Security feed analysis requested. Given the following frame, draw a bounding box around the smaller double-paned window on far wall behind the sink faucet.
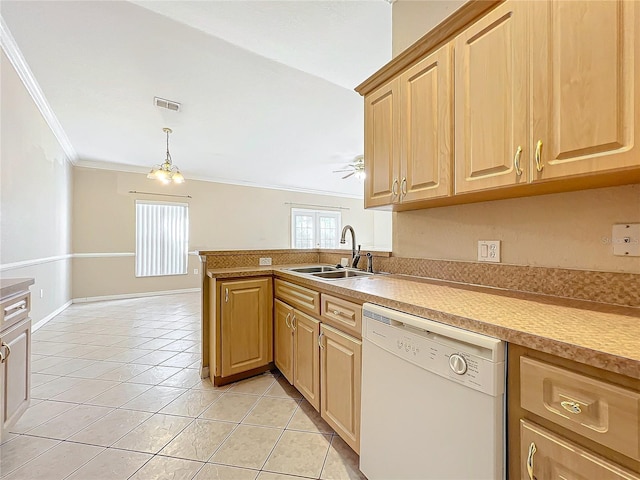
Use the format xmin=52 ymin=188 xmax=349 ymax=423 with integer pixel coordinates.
xmin=291 ymin=208 xmax=342 ymax=248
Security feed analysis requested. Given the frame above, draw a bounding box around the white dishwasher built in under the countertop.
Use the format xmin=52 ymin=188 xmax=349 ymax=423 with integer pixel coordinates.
xmin=360 ymin=303 xmax=506 ymax=480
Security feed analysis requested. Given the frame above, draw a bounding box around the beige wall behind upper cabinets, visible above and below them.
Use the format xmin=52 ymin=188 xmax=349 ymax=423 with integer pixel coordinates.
xmin=393 ymin=0 xmax=640 ymax=273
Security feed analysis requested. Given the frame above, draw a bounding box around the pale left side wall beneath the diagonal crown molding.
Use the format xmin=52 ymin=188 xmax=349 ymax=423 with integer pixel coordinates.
xmin=0 ymin=52 xmax=72 ymax=323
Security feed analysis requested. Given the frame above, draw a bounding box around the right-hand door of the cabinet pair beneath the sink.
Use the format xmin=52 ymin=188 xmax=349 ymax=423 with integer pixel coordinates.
xmin=293 ymin=311 xmax=320 ymax=411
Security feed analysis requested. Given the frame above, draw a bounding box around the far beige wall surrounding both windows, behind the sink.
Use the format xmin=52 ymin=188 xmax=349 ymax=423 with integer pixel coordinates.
xmin=73 ymin=168 xmax=391 ymax=298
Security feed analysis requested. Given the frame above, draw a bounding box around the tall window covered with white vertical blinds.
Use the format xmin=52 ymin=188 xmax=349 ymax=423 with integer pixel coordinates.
xmin=136 ymin=200 xmax=189 ymax=277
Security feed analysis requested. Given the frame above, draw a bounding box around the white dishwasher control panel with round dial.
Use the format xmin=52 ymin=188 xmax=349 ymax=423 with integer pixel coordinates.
xmin=362 ymin=310 xmax=505 ymax=395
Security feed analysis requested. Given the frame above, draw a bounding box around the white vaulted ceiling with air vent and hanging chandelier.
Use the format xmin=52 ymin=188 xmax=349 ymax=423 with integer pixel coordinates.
xmin=0 ymin=0 xmax=391 ymax=197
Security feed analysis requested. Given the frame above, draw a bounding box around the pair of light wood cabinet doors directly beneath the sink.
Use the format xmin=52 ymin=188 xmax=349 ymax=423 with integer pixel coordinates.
xmin=274 ymin=299 xmax=320 ymax=411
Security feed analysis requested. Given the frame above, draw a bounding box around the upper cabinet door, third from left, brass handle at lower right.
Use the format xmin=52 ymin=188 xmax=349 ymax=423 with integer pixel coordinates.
xmin=455 ymin=1 xmax=530 ymax=193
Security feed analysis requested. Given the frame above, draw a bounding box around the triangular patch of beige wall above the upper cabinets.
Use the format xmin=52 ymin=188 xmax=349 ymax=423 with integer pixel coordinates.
xmin=391 ymin=0 xmax=466 ymax=57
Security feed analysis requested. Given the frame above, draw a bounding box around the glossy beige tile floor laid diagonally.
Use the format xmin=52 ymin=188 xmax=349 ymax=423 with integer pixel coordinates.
xmin=0 ymin=293 xmax=364 ymax=480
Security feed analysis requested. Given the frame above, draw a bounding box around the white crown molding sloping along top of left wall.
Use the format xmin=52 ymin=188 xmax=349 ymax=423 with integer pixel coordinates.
xmin=0 ymin=15 xmax=78 ymax=165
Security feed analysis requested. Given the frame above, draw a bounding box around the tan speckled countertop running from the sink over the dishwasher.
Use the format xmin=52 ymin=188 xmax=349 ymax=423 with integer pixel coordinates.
xmin=207 ymin=265 xmax=640 ymax=379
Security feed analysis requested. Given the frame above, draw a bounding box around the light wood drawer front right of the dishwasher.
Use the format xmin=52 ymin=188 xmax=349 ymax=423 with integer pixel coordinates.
xmin=520 ymin=357 xmax=640 ymax=460
